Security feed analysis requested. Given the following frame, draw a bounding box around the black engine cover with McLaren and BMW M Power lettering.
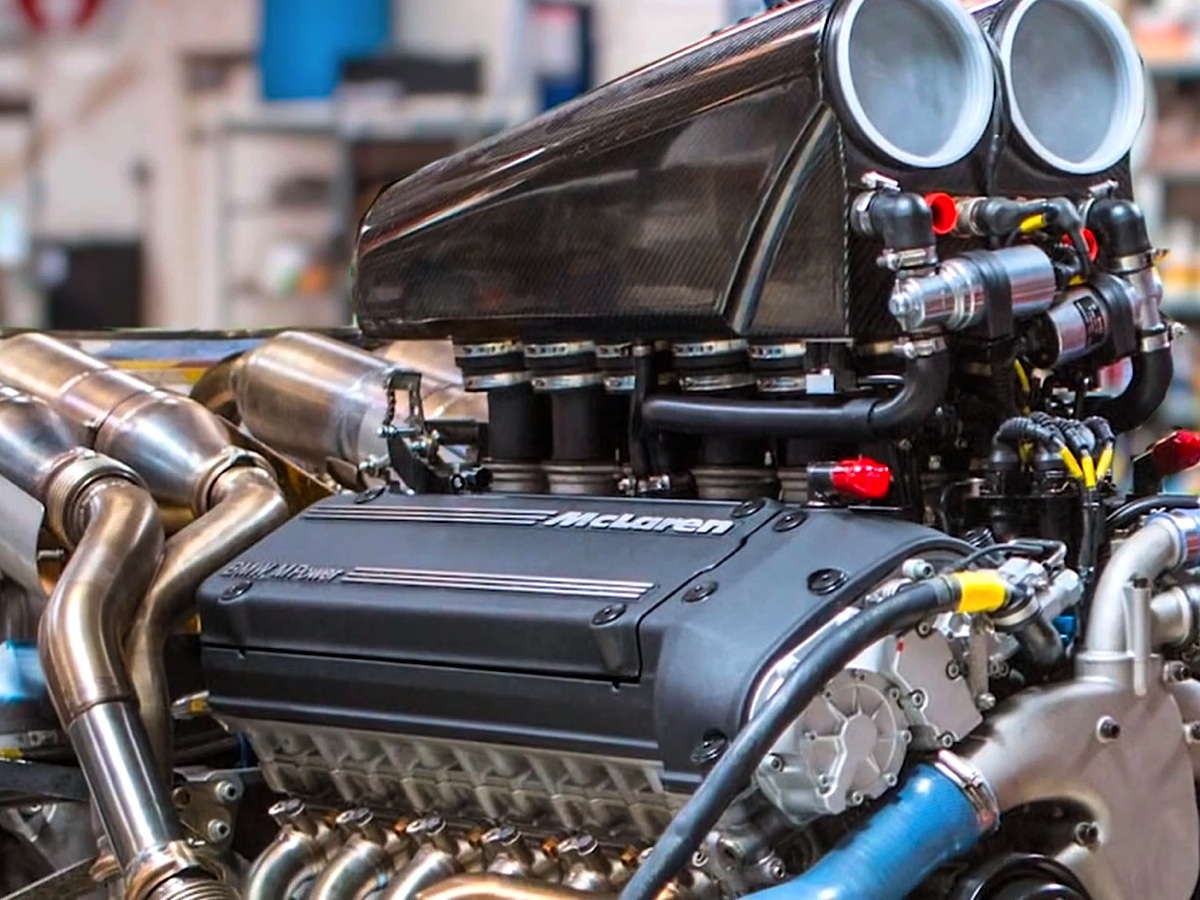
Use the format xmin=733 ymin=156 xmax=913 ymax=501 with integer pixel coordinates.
xmin=199 ymin=494 xmax=962 ymax=785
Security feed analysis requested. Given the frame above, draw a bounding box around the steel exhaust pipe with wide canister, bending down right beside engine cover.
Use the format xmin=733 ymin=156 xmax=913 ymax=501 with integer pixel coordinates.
xmin=0 ymin=334 xmax=288 ymax=778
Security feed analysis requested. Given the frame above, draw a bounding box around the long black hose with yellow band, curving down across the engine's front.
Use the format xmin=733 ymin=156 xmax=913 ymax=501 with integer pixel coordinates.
xmin=618 ymin=576 xmax=984 ymax=900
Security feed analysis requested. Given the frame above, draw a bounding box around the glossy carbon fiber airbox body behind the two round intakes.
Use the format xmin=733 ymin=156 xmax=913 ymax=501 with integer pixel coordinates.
xmin=354 ymin=0 xmax=1128 ymax=340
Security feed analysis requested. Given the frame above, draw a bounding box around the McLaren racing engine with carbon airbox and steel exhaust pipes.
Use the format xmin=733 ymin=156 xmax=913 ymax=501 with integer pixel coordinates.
xmin=0 ymin=0 xmax=1200 ymax=900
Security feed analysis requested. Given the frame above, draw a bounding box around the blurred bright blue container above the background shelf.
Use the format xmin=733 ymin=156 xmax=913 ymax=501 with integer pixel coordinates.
xmin=258 ymin=0 xmax=391 ymax=100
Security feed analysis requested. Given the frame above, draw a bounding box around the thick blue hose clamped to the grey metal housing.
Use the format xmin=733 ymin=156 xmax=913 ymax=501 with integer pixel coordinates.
xmin=750 ymin=766 xmax=992 ymax=900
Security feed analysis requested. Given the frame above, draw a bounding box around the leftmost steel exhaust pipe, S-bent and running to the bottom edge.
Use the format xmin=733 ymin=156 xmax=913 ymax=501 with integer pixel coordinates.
xmin=0 ymin=391 xmax=232 ymax=900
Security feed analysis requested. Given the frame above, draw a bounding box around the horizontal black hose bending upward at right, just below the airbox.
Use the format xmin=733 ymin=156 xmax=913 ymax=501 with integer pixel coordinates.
xmin=642 ymin=352 xmax=950 ymax=442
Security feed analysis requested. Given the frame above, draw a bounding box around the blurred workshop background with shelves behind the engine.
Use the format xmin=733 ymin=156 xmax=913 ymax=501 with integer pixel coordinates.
xmin=0 ymin=0 xmax=1200 ymax=458
